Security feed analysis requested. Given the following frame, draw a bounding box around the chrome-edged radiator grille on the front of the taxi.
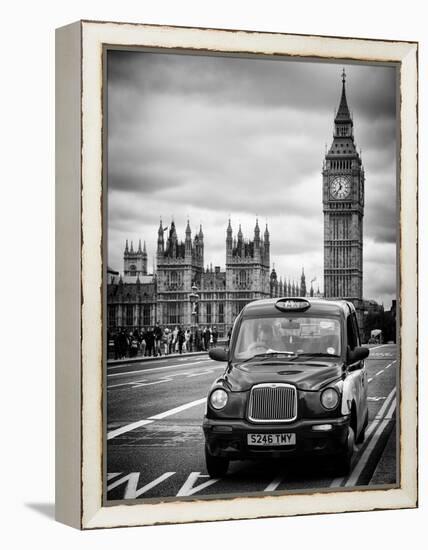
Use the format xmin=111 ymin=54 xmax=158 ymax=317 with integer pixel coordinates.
xmin=248 ymin=384 xmax=297 ymax=422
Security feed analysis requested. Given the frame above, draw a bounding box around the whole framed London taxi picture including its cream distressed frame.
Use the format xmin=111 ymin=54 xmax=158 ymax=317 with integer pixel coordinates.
xmin=56 ymin=21 xmax=418 ymax=529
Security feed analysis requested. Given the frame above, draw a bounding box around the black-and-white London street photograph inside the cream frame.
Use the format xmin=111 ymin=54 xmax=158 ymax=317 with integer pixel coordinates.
xmin=103 ymin=47 xmax=400 ymax=504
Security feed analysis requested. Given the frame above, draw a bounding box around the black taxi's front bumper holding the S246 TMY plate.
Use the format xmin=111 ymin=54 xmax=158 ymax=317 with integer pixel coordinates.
xmin=202 ymin=416 xmax=350 ymax=460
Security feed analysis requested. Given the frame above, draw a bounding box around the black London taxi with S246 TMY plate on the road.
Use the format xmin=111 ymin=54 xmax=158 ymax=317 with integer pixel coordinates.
xmin=203 ymin=298 xmax=369 ymax=477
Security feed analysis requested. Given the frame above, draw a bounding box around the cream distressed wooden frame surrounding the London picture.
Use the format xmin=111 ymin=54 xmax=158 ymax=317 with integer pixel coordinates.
xmin=56 ymin=21 xmax=418 ymax=529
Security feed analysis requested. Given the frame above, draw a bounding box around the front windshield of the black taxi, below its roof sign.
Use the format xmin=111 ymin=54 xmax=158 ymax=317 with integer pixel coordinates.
xmin=233 ymin=315 xmax=341 ymax=361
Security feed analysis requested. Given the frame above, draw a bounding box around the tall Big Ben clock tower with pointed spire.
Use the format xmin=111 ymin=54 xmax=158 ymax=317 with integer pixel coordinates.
xmin=323 ymin=70 xmax=364 ymax=329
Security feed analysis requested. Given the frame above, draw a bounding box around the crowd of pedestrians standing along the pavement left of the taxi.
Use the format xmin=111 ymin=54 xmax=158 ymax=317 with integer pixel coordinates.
xmin=107 ymin=323 xmax=218 ymax=359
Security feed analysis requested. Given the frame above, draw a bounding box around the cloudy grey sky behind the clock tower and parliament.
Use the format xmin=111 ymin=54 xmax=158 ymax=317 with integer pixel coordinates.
xmin=107 ymin=51 xmax=396 ymax=308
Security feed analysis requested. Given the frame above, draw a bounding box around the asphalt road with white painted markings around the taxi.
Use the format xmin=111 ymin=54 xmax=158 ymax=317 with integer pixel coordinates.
xmin=106 ymin=344 xmax=397 ymax=501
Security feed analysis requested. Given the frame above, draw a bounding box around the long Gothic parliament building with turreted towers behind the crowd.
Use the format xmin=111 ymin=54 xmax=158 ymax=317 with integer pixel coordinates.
xmin=107 ymin=220 xmax=313 ymax=336
